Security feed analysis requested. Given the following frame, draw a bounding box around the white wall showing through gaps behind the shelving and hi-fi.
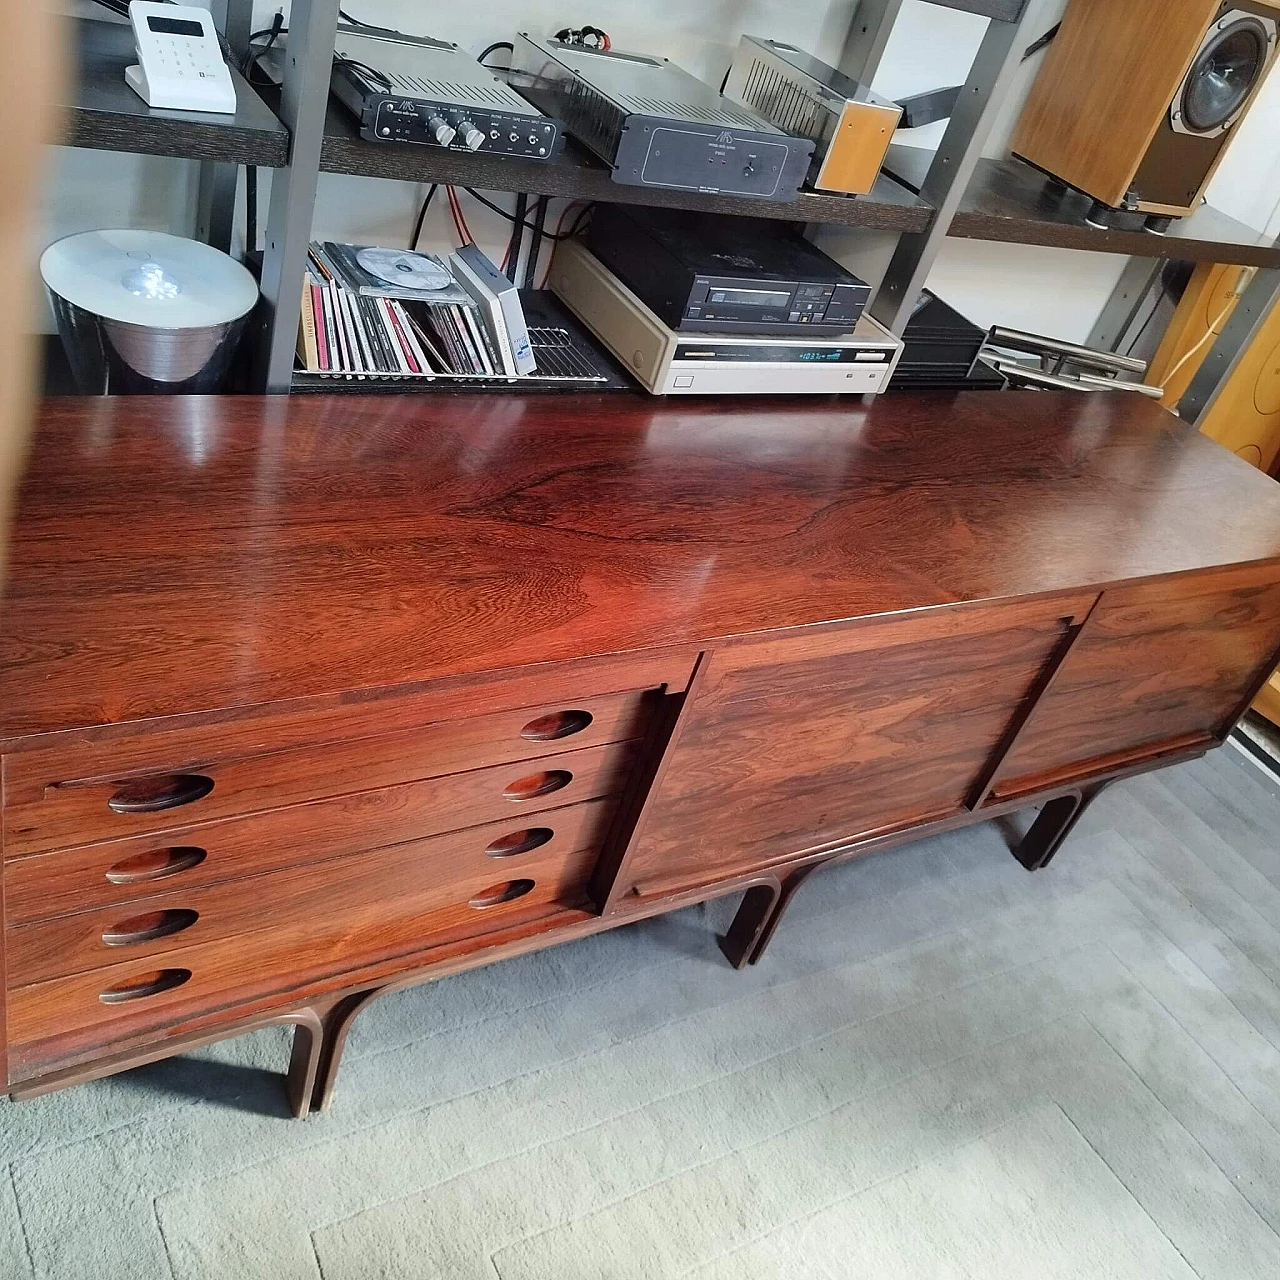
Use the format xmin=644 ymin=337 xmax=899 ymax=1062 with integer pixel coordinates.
xmin=32 ymin=0 xmax=1280 ymax=340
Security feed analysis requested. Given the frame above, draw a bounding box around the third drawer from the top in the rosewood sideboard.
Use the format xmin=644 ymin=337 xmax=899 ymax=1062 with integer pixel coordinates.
xmin=6 ymin=797 xmax=614 ymax=987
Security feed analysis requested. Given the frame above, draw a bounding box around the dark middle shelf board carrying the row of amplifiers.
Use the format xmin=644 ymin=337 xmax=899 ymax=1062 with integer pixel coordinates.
xmin=320 ymin=100 xmax=932 ymax=232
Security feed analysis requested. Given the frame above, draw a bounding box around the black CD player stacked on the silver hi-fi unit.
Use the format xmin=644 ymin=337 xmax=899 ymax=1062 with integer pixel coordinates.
xmin=588 ymin=205 xmax=872 ymax=334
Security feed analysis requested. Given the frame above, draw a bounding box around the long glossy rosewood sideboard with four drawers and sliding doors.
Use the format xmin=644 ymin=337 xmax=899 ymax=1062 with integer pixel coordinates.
xmin=0 ymin=393 xmax=1280 ymax=1115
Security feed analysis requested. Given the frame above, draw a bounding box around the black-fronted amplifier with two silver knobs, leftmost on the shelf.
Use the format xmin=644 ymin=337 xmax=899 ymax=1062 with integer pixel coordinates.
xmin=330 ymin=27 xmax=563 ymax=160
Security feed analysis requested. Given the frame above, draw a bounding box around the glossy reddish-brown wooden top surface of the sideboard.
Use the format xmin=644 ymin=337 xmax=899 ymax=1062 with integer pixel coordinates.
xmin=0 ymin=392 xmax=1280 ymax=737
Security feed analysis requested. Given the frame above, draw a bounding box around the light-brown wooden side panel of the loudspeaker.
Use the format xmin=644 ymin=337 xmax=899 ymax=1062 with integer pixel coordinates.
xmin=1011 ymin=0 xmax=1220 ymax=206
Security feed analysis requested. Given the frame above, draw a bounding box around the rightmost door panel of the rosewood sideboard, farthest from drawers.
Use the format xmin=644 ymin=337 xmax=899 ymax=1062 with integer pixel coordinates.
xmin=993 ymin=564 xmax=1280 ymax=799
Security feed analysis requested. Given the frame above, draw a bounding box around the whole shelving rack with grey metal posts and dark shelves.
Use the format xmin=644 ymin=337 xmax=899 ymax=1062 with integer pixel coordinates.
xmin=57 ymin=0 xmax=1280 ymax=401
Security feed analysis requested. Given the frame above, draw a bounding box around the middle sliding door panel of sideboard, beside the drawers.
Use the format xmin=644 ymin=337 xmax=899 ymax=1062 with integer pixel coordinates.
xmin=627 ymin=596 xmax=1093 ymax=896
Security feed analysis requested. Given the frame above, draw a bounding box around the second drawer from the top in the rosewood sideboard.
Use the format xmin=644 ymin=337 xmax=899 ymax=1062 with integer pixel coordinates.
xmin=4 ymin=744 xmax=636 ymax=927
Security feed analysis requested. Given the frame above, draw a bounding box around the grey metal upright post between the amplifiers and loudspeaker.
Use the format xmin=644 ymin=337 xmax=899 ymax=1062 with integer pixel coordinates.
xmin=870 ymin=0 xmax=1028 ymax=337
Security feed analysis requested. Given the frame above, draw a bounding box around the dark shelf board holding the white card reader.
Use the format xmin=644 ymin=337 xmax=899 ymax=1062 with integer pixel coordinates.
xmin=63 ymin=18 xmax=289 ymax=169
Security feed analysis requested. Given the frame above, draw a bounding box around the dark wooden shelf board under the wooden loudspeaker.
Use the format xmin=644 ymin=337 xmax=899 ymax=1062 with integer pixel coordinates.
xmin=888 ymin=146 xmax=1280 ymax=266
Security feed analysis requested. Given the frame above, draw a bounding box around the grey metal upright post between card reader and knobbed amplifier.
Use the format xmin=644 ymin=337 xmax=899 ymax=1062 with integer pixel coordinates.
xmin=259 ymin=0 xmax=338 ymax=394
